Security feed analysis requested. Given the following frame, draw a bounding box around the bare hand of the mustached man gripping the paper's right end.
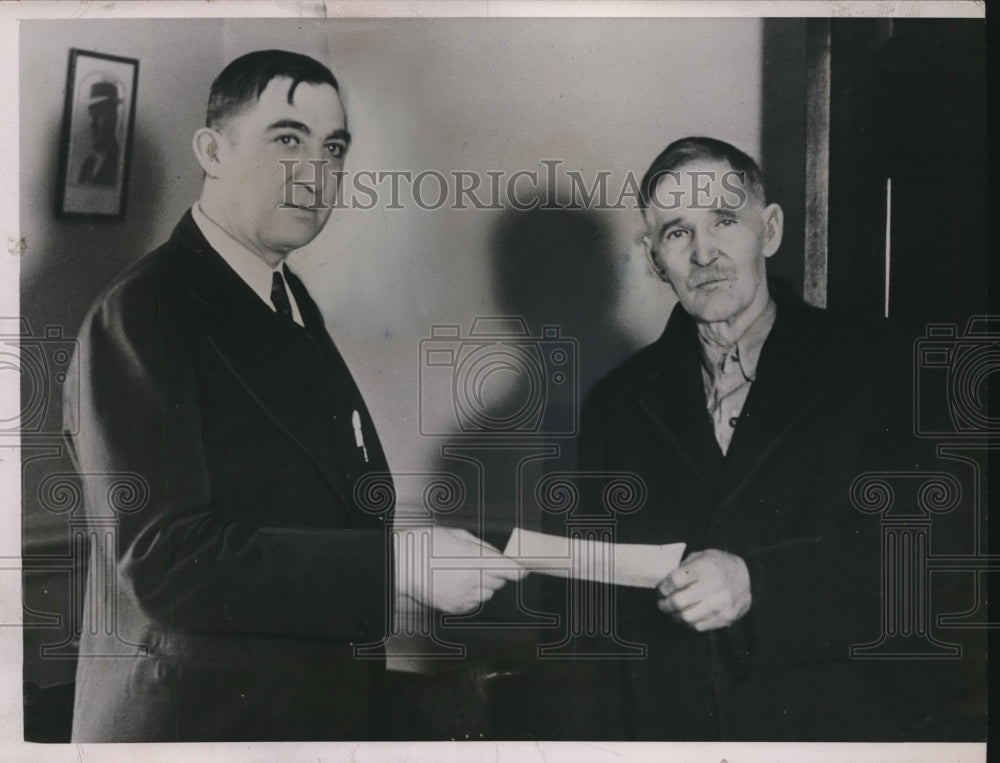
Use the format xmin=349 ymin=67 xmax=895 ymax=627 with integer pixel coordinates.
xmin=657 ymin=548 xmax=751 ymax=631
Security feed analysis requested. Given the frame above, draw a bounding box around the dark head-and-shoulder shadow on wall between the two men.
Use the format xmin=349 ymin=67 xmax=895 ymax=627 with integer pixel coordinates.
xmin=428 ymin=201 xmax=634 ymax=546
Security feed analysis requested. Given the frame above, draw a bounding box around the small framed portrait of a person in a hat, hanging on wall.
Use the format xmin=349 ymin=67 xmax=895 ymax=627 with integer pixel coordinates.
xmin=56 ymin=48 xmax=139 ymax=220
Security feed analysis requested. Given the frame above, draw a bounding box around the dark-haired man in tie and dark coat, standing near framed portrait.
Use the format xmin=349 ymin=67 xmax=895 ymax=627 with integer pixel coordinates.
xmin=66 ymin=51 xmax=516 ymax=742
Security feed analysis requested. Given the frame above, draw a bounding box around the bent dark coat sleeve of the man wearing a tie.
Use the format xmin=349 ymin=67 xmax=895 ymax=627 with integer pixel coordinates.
xmin=64 ymin=280 xmax=392 ymax=642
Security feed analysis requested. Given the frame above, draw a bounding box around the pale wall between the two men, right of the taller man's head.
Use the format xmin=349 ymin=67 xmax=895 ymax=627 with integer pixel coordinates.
xmin=225 ymin=19 xmax=762 ymax=480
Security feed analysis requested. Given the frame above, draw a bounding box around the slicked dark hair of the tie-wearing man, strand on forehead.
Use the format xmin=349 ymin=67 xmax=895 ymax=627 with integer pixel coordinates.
xmin=205 ymin=50 xmax=340 ymax=130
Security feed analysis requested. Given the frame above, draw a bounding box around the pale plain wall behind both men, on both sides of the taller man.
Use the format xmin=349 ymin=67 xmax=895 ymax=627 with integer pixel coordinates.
xmin=20 ymin=19 xmax=764 ymax=682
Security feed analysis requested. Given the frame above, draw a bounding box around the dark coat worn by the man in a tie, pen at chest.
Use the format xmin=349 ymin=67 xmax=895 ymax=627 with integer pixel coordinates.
xmin=65 ymin=212 xmax=392 ymax=742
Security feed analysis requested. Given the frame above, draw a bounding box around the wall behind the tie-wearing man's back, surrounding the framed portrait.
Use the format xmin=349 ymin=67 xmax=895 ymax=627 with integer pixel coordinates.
xmin=19 ymin=21 xmax=225 ymax=686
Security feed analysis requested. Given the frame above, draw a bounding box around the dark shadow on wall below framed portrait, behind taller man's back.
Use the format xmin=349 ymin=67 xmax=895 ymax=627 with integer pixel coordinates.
xmin=21 ymin=116 xmax=164 ymax=742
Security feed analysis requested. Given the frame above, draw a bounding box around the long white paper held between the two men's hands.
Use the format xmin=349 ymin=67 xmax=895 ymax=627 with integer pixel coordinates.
xmin=503 ymin=527 xmax=686 ymax=588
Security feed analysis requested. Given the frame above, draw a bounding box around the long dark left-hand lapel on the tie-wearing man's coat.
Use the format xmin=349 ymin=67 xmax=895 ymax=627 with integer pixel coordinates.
xmin=168 ymin=212 xmax=353 ymax=508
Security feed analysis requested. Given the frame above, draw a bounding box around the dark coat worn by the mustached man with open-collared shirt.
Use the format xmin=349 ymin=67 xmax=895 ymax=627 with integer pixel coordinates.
xmin=544 ymin=282 xmax=981 ymax=740
